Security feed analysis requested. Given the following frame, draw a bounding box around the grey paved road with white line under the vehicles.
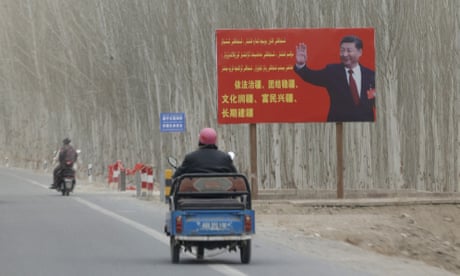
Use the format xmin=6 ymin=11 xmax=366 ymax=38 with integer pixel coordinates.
xmin=0 ymin=168 xmax=452 ymax=276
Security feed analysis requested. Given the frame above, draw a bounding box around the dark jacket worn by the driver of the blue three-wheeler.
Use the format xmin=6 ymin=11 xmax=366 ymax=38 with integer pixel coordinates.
xmin=173 ymin=145 xmax=237 ymax=178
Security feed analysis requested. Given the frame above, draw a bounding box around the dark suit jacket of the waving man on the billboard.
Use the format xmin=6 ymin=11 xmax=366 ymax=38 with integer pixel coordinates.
xmin=294 ymin=64 xmax=375 ymax=122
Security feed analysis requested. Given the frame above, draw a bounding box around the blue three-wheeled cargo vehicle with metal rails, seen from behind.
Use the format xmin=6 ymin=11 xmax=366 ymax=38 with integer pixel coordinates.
xmin=164 ymin=157 xmax=255 ymax=264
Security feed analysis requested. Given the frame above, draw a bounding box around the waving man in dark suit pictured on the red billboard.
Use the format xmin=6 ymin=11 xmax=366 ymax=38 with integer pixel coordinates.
xmin=294 ymin=35 xmax=375 ymax=122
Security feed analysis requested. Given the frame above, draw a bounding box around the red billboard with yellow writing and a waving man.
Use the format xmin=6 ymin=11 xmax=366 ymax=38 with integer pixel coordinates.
xmin=216 ymin=28 xmax=375 ymax=124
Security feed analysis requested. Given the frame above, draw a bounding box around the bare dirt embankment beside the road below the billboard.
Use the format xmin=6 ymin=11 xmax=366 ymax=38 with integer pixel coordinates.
xmin=255 ymin=199 xmax=460 ymax=275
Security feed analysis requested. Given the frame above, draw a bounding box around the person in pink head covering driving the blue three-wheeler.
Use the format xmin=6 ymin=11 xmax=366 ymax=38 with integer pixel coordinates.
xmin=173 ymin=127 xmax=237 ymax=178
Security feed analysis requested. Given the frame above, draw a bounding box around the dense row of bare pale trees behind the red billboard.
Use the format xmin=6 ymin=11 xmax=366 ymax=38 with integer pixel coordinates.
xmin=0 ymin=0 xmax=460 ymax=195
